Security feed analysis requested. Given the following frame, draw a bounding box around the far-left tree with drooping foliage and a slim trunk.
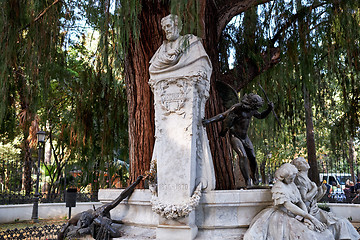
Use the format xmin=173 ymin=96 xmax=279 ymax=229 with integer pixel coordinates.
xmin=0 ymin=0 xmax=61 ymax=193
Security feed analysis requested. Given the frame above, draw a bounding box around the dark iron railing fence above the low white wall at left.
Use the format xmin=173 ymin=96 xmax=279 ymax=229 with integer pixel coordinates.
xmin=0 ymin=156 xmax=125 ymax=205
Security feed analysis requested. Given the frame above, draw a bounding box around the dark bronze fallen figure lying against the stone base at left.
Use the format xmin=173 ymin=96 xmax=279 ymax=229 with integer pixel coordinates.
xmin=58 ymin=176 xmax=143 ymax=240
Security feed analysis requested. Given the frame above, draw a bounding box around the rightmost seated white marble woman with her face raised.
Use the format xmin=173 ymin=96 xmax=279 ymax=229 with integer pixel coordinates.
xmin=292 ymin=157 xmax=360 ymax=240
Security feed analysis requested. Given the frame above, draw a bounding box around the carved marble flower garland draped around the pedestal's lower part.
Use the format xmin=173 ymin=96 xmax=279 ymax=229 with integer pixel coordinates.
xmin=149 ymin=159 xmax=202 ymax=219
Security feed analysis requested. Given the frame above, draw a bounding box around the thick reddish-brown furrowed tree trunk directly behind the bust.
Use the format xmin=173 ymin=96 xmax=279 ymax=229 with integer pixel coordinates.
xmin=125 ymin=0 xmax=269 ymax=189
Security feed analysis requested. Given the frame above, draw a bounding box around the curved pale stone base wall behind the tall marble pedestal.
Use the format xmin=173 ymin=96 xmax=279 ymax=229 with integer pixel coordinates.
xmin=99 ymin=189 xmax=272 ymax=240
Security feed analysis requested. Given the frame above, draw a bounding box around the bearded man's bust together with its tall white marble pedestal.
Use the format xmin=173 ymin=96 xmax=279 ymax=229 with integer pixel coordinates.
xmin=149 ymin=15 xmax=215 ymax=239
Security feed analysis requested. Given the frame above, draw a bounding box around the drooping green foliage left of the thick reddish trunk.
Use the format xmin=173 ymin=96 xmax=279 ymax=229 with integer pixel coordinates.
xmin=0 ymin=0 xmax=128 ymax=194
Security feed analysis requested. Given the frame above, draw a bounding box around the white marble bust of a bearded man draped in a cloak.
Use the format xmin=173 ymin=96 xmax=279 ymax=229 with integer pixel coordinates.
xmin=149 ymin=14 xmax=212 ymax=80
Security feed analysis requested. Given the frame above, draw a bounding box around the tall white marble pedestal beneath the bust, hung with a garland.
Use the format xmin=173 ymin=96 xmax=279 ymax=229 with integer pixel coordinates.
xmin=149 ymin=71 xmax=215 ymax=240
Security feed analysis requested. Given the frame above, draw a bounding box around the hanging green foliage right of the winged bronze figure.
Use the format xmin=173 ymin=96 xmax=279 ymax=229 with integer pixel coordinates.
xmin=225 ymin=1 xmax=359 ymax=183
